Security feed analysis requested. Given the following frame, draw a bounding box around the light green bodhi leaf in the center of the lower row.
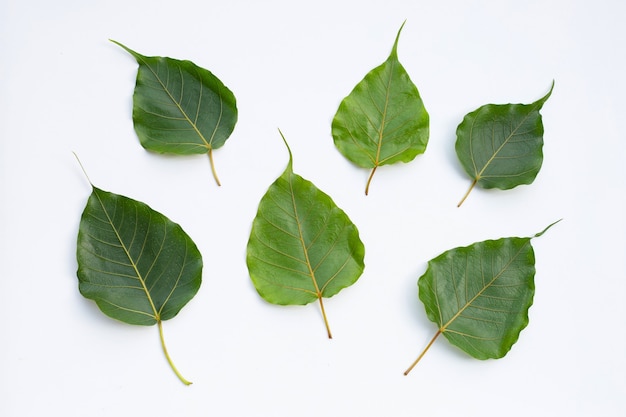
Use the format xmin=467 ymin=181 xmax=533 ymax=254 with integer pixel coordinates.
xmin=246 ymin=133 xmax=365 ymax=338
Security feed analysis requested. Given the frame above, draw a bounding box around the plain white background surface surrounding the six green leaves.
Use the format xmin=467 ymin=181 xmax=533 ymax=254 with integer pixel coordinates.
xmin=0 ymin=0 xmax=626 ymax=417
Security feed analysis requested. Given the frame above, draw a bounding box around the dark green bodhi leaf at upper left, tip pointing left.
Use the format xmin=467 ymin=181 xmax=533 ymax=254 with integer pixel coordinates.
xmin=111 ymin=41 xmax=237 ymax=185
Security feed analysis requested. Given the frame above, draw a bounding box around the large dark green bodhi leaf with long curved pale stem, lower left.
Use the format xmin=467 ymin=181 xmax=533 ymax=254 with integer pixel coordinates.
xmin=76 ymin=158 xmax=202 ymax=385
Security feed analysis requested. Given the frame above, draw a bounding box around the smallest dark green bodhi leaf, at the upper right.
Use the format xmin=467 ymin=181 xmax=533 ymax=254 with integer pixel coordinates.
xmin=455 ymin=82 xmax=554 ymax=207
